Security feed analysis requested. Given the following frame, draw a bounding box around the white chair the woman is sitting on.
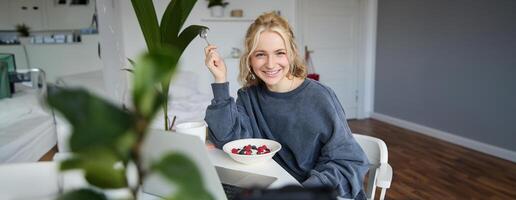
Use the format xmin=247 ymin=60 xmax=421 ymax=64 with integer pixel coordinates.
xmin=353 ymin=133 xmax=392 ymax=200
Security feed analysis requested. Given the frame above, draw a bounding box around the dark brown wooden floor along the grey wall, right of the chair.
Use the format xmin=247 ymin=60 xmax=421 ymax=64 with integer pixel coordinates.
xmin=348 ymin=119 xmax=516 ymax=200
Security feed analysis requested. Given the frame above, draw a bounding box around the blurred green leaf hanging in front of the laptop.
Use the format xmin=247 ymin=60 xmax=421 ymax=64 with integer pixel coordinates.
xmin=152 ymin=153 xmax=213 ymax=199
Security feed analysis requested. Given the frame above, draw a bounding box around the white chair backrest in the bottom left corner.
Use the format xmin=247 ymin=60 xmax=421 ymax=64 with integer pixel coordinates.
xmin=0 ymin=162 xmax=59 ymax=199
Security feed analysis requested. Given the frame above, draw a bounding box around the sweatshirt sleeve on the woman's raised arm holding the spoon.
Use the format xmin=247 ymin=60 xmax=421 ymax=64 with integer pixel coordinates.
xmin=204 ymin=82 xmax=252 ymax=148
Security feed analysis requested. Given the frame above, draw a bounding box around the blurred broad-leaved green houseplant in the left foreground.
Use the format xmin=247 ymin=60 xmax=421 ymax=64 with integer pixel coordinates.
xmin=47 ymin=48 xmax=213 ymax=200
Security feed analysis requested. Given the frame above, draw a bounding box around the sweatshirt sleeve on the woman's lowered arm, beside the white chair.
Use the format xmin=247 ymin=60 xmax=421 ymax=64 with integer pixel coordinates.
xmin=302 ymin=87 xmax=369 ymax=199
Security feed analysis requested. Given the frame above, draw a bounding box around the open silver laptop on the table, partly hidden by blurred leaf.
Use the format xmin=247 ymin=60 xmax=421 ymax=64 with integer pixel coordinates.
xmin=142 ymin=130 xmax=277 ymax=199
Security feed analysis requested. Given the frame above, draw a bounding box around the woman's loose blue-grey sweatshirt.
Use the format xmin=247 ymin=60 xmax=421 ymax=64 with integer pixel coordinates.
xmin=205 ymin=79 xmax=369 ymax=199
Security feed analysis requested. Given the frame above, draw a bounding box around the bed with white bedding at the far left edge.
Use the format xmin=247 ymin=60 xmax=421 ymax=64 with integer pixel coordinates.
xmin=0 ymin=79 xmax=57 ymax=163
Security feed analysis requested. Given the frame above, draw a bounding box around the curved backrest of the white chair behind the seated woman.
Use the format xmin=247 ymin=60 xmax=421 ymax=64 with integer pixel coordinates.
xmin=353 ymin=133 xmax=388 ymax=199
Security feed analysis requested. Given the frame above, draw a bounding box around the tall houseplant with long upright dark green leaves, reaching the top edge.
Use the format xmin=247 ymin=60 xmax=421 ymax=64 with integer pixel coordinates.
xmin=131 ymin=0 xmax=207 ymax=130
